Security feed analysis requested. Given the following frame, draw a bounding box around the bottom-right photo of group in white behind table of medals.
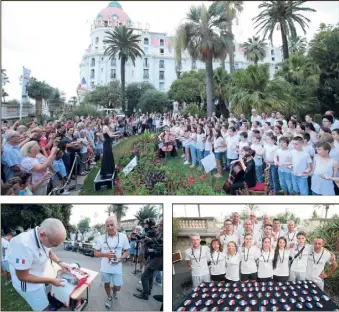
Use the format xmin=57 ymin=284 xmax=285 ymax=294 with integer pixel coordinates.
xmin=172 ymin=204 xmax=339 ymax=311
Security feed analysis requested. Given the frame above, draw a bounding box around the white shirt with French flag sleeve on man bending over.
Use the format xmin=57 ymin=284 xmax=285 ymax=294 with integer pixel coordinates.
xmin=7 ymin=228 xmax=50 ymax=292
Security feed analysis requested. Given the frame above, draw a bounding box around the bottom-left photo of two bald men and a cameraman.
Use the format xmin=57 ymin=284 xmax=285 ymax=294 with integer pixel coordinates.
xmin=1 ymin=204 xmax=163 ymax=311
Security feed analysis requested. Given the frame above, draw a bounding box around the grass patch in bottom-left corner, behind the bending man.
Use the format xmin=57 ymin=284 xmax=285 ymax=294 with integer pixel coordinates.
xmin=1 ymin=277 xmax=32 ymax=311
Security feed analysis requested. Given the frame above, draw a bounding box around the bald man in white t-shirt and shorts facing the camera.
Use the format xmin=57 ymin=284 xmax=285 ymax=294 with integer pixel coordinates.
xmin=94 ymin=216 xmax=129 ymax=309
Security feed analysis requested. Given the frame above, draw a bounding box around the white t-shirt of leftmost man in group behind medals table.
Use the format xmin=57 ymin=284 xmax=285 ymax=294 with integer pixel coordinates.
xmin=185 ymin=246 xmax=211 ymax=276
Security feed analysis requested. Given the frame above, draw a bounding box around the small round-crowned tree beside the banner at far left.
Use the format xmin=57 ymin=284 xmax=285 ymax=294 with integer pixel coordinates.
xmin=26 ymin=77 xmax=54 ymax=116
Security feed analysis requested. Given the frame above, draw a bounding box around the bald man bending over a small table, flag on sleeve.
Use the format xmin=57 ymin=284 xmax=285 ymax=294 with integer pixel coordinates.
xmin=8 ymin=218 xmax=70 ymax=311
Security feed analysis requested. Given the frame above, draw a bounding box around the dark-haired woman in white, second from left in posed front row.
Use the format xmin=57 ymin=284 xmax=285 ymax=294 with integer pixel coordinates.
xmin=211 ymin=238 xmax=226 ymax=282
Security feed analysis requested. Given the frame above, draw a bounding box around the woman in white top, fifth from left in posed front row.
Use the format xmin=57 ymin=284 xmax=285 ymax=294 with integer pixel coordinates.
xmin=258 ymin=237 xmax=274 ymax=282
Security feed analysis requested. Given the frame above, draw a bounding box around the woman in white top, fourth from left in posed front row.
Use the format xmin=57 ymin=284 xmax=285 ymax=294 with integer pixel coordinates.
xmin=240 ymin=234 xmax=260 ymax=282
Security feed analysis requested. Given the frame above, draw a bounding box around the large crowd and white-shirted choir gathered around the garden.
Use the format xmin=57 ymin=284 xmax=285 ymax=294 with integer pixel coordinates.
xmin=1 ymin=109 xmax=339 ymax=195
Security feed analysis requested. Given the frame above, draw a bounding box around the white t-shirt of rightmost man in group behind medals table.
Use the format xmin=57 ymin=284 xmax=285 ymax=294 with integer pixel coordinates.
xmin=306 ymin=248 xmax=331 ymax=282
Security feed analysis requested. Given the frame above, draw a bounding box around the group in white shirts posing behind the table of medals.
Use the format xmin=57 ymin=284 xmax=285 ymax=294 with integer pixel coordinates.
xmin=185 ymin=212 xmax=338 ymax=290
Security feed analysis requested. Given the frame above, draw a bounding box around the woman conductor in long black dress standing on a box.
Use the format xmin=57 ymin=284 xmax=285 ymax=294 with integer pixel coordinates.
xmin=100 ymin=116 xmax=119 ymax=179
